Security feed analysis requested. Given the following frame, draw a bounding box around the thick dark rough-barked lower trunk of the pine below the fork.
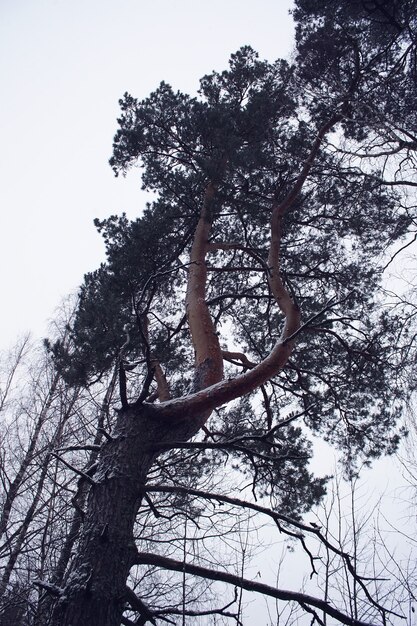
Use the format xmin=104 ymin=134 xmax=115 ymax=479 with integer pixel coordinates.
xmin=48 ymin=407 xmax=199 ymax=626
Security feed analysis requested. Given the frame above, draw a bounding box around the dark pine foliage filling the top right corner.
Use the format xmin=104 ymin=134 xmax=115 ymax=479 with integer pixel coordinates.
xmin=293 ymin=0 xmax=417 ymax=136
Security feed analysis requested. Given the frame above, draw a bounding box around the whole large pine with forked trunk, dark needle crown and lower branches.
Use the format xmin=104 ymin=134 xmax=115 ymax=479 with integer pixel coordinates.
xmin=1 ymin=2 xmax=416 ymax=625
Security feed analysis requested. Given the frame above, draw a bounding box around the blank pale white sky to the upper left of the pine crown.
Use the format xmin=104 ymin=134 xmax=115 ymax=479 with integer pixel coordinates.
xmin=0 ymin=0 xmax=293 ymax=348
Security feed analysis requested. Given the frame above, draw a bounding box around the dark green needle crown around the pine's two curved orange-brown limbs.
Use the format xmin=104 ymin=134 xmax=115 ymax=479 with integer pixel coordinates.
xmin=53 ymin=42 xmax=412 ymax=515
